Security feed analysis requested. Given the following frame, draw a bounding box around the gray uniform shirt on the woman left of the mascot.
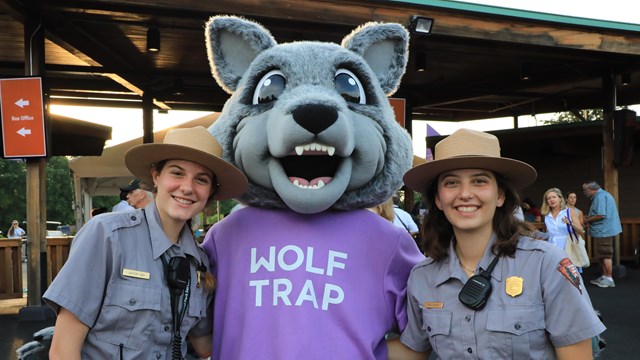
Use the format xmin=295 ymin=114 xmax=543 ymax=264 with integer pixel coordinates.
xmin=43 ymin=202 xmax=212 ymax=359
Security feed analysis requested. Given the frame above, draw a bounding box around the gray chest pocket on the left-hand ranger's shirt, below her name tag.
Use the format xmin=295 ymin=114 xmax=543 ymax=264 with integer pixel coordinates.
xmin=93 ymin=282 xmax=162 ymax=350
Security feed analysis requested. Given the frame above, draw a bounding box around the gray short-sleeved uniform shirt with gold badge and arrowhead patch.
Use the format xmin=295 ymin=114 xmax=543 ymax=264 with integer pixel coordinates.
xmin=401 ymin=237 xmax=605 ymax=359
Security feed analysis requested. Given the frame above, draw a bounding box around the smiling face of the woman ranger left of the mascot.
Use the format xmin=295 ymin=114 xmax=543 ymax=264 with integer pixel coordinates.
xmin=153 ymin=160 xmax=214 ymax=226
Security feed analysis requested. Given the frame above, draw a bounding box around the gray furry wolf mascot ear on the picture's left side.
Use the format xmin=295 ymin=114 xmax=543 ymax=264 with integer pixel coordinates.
xmin=205 ymin=16 xmax=277 ymax=94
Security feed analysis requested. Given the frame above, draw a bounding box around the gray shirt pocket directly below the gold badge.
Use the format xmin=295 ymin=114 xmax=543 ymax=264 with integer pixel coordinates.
xmin=487 ymin=305 xmax=555 ymax=359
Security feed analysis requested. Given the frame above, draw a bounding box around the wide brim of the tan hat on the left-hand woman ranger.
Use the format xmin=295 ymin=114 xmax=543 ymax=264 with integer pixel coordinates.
xmin=124 ymin=144 xmax=248 ymax=200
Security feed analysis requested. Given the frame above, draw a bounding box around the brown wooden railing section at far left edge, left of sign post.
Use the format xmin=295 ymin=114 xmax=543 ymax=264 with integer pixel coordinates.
xmin=0 ymin=239 xmax=22 ymax=299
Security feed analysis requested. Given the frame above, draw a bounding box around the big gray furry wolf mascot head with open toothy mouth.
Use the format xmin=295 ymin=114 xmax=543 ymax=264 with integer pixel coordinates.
xmin=206 ymin=16 xmax=412 ymax=214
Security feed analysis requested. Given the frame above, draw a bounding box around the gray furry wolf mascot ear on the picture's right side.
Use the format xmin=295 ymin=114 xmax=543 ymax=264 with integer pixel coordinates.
xmin=342 ymin=22 xmax=409 ymax=96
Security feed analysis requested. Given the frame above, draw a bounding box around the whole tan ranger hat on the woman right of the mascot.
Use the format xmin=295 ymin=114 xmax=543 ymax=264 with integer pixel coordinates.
xmin=404 ymin=129 xmax=538 ymax=193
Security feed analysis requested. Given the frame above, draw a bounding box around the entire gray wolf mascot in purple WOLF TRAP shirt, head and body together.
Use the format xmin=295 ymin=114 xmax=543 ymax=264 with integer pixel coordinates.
xmin=204 ymin=16 xmax=423 ymax=360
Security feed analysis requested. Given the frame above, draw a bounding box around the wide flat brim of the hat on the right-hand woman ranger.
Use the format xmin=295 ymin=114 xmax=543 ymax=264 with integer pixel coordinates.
xmin=403 ymin=156 xmax=538 ymax=193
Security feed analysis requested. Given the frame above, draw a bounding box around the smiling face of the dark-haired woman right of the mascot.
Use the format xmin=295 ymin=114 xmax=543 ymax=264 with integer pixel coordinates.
xmin=435 ymin=169 xmax=505 ymax=234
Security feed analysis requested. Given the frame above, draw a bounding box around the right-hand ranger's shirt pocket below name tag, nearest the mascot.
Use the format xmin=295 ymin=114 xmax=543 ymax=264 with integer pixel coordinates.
xmin=422 ymin=309 xmax=454 ymax=354
